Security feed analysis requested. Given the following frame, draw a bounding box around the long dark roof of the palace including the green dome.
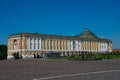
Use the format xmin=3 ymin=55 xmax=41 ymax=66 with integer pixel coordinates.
xmin=8 ymin=29 xmax=111 ymax=42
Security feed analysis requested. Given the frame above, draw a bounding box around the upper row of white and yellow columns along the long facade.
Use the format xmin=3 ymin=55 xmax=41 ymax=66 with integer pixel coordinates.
xmin=27 ymin=38 xmax=110 ymax=51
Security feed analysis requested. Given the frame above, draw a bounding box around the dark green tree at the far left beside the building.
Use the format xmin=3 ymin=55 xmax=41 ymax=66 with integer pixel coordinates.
xmin=0 ymin=44 xmax=7 ymax=60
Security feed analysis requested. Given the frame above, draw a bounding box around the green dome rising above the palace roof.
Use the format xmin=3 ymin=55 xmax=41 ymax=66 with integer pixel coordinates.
xmin=77 ymin=29 xmax=97 ymax=39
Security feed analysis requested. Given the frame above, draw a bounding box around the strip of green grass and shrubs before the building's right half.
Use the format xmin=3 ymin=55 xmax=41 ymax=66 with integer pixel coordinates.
xmin=68 ymin=53 xmax=120 ymax=60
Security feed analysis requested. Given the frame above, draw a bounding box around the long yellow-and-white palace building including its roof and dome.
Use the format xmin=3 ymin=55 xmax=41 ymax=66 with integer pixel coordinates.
xmin=7 ymin=29 xmax=112 ymax=59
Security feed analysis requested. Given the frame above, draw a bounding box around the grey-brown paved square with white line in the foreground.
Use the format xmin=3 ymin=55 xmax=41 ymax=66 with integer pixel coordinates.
xmin=0 ymin=59 xmax=120 ymax=80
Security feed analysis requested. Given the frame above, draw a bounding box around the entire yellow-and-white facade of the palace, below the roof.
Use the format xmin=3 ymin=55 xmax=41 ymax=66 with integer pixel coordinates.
xmin=8 ymin=37 xmax=112 ymax=58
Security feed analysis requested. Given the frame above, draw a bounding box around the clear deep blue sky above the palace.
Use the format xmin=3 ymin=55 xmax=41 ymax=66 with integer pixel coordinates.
xmin=0 ymin=0 xmax=120 ymax=48
